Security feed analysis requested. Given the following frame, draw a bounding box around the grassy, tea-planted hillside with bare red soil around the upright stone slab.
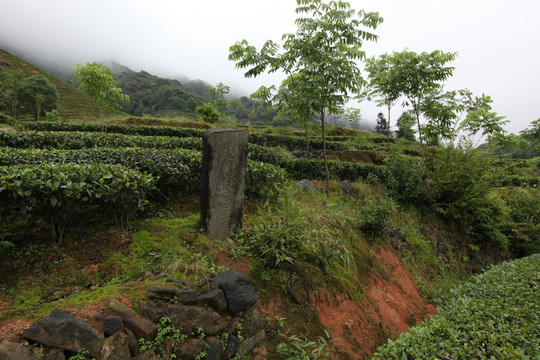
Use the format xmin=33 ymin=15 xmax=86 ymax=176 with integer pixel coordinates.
xmin=0 ymin=118 xmax=540 ymax=359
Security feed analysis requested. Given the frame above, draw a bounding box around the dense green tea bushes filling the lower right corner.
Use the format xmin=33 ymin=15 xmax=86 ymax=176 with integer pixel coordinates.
xmin=373 ymin=254 xmax=540 ymax=359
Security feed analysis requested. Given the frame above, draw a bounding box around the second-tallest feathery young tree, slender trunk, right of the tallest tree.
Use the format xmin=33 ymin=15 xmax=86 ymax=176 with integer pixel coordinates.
xmin=388 ymin=50 xmax=457 ymax=143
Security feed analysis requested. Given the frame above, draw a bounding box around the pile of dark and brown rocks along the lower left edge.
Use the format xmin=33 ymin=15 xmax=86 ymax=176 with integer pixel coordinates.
xmin=0 ymin=271 xmax=265 ymax=360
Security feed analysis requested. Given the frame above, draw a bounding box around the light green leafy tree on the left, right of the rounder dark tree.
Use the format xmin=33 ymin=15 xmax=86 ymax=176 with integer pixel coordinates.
xmin=71 ymin=62 xmax=129 ymax=116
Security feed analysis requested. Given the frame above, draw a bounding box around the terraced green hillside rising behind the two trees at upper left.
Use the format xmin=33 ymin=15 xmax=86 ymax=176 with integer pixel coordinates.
xmin=0 ymin=49 xmax=110 ymax=120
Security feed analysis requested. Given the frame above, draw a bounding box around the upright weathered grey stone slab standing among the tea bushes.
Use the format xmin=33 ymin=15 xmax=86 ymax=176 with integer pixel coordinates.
xmin=201 ymin=129 xmax=249 ymax=240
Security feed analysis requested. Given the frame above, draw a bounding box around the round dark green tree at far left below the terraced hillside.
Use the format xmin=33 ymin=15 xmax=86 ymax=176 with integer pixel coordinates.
xmin=17 ymin=75 xmax=60 ymax=120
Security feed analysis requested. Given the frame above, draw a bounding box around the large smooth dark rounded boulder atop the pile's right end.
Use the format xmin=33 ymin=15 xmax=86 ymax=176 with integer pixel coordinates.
xmin=211 ymin=271 xmax=259 ymax=314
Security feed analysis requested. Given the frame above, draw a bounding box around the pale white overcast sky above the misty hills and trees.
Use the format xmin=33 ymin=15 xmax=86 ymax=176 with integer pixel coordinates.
xmin=0 ymin=0 xmax=540 ymax=132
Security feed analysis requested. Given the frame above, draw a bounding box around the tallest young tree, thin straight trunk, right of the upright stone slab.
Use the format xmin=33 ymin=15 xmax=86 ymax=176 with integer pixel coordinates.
xmin=229 ymin=0 xmax=383 ymax=192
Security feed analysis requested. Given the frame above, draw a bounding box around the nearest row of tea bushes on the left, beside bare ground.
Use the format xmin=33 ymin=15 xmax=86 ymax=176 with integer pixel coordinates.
xmin=0 ymin=163 xmax=156 ymax=243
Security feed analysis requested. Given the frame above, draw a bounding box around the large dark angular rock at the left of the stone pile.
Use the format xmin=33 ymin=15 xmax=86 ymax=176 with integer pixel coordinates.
xmin=22 ymin=309 xmax=103 ymax=357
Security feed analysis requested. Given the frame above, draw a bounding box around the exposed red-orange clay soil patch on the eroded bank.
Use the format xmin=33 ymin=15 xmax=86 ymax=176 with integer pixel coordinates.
xmin=312 ymin=247 xmax=437 ymax=359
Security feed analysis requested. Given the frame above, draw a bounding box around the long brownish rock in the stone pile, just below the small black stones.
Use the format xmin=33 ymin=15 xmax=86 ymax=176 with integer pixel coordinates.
xmin=139 ymin=302 xmax=223 ymax=335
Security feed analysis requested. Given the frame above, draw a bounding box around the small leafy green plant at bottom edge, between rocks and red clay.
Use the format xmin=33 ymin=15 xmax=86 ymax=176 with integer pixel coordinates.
xmin=277 ymin=331 xmax=337 ymax=360
